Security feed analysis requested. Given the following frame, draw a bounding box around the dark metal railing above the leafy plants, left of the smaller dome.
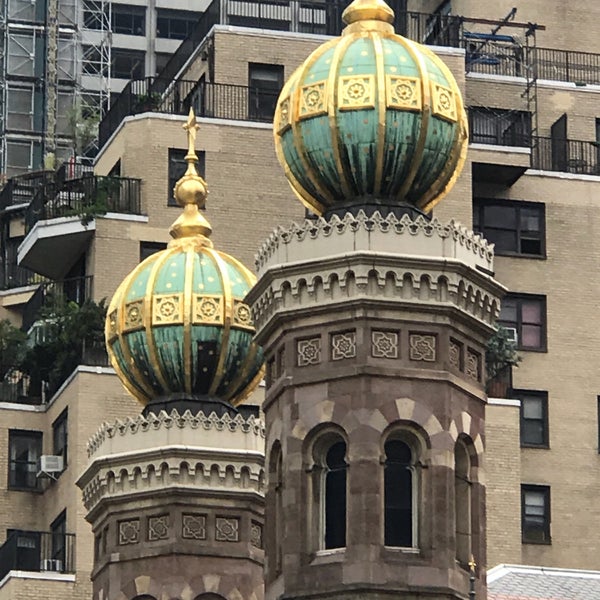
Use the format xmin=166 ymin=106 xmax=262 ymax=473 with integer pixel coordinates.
xmin=22 ymin=275 xmax=94 ymax=331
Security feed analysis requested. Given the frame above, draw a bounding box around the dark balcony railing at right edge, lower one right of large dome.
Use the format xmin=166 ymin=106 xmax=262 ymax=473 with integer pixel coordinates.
xmin=531 ymin=137 xmax=600 ymax=175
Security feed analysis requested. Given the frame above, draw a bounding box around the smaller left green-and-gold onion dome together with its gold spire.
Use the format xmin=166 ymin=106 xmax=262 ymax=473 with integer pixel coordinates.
xmin=105 ymin=111 xmax=263 ymax=409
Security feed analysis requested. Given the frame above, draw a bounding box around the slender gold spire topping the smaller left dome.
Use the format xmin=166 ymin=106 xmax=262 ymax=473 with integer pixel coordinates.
xmin=169 ymin=108 xmax=212 ymax=247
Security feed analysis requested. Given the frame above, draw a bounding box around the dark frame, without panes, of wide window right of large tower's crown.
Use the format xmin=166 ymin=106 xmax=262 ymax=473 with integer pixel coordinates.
xmin=473 ymin=197 xmax=547 ymax=260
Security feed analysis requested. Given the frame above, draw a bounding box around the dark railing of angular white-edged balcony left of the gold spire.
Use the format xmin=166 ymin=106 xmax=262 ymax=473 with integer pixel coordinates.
xmin=25 ymin=175 xmax=141 ymax=233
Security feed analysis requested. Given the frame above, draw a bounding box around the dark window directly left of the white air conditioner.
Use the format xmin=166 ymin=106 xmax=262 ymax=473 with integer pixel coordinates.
xmin=8 ymin=430 xmax=42 ymax=490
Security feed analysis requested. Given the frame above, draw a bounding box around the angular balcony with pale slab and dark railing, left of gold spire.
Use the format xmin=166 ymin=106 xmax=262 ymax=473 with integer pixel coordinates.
xmin=17 ymin=174 xmax=141 ymax=279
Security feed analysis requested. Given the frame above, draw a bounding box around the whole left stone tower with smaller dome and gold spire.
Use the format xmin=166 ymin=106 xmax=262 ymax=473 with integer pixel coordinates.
xmin=78 ymin=113 xmax=265 ymax=600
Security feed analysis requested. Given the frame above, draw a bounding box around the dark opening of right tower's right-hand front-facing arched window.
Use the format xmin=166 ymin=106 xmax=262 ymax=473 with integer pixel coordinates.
xmin=384 ymin=439 xmax=417 ymax=548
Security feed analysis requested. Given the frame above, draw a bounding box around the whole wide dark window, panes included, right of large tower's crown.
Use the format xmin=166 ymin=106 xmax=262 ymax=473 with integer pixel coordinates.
xmin=473 ymin=199 xmax=545 ymax=256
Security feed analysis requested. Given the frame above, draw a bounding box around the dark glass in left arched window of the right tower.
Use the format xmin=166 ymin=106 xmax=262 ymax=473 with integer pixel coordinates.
xmin=324 ymin=442 xmax=348 ymax=548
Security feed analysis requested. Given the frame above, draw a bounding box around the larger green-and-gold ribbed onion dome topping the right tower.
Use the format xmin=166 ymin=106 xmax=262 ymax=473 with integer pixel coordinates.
xmin=274 ymin=0 xmax=468 ymax=215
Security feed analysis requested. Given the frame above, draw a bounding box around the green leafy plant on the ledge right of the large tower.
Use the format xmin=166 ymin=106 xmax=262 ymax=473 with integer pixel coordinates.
xmin=485 ymin=326 xmax=521 ymax=398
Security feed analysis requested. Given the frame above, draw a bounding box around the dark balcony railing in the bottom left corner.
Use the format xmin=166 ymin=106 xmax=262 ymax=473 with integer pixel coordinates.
xmin=0 ymin=530 xmax=75 ymax=581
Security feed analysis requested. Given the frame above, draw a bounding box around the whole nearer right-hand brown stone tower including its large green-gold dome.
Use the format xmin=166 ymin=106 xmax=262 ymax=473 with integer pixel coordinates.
xmin=249 ymin=0 xmax=503 ymax=600
